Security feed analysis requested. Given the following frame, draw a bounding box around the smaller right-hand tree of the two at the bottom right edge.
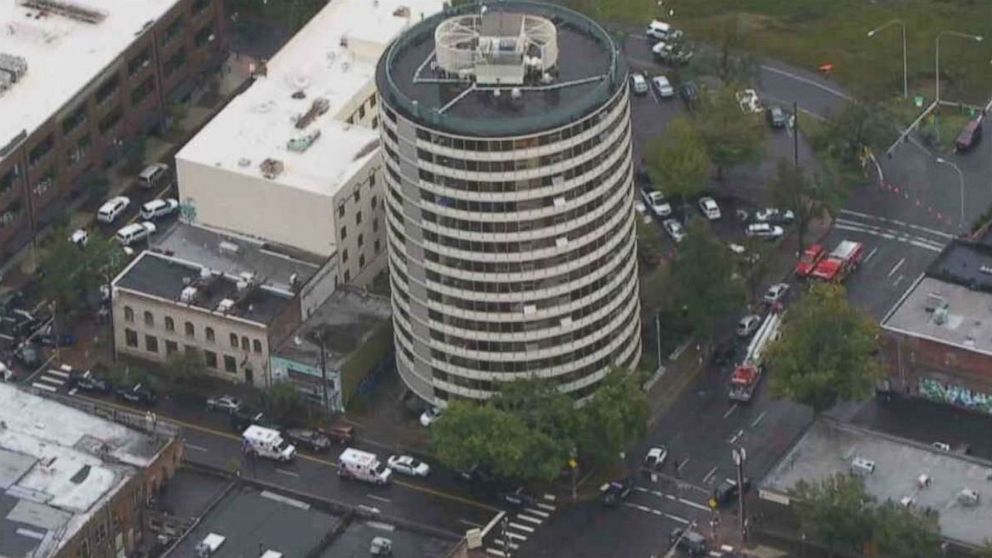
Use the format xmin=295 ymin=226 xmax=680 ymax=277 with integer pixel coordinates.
xmin=872 ymin=500 xmax=941 ymax=558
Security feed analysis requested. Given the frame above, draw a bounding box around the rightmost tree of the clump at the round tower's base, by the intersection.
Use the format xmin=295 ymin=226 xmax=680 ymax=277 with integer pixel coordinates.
xmin=579 ymin=369 xmax=649 ymax=472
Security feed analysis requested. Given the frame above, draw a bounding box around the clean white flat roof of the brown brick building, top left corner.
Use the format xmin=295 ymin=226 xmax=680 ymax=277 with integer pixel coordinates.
xmin=0 ymin=0 xmax=177 ymax=155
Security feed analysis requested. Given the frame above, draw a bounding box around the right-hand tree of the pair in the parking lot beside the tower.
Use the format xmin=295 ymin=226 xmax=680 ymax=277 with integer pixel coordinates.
xmin=695 ymin=87 xmax=767 ymax=180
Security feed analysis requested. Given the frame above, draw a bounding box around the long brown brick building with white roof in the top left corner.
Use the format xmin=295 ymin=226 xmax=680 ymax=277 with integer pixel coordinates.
xmin=0 ymin=0 xmax=224 ymax=259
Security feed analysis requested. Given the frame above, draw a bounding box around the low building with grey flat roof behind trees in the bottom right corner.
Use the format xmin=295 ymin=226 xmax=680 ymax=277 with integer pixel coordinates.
xmin=752 ymin=418 xmax=992 ymax=555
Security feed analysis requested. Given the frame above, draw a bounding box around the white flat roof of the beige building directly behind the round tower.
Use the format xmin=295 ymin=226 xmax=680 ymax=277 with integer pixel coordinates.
xmin=176 ymin=0 xmax=443 ymax=195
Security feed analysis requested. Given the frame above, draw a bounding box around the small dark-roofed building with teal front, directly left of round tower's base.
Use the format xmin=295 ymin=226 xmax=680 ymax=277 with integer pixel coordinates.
xmin=272 ymin=286 xmax=392 ymax=412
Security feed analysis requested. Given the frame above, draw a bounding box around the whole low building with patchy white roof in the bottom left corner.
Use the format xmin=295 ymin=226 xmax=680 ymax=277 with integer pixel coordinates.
xmin=0 ymin=383 xmax=183 ymax=558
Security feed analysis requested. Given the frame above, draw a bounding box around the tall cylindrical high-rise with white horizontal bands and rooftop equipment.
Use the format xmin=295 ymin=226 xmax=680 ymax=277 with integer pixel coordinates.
xmin=376 ymin=0 xmax=640 ymax=405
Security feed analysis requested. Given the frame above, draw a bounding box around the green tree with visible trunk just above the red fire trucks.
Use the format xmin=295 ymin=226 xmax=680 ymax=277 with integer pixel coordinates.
xmin=769 ymin=159 xmax=841 ymax=253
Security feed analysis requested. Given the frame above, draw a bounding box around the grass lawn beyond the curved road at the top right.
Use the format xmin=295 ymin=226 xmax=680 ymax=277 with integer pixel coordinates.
xmin=559 ymin=0 xmax=992 ymax=104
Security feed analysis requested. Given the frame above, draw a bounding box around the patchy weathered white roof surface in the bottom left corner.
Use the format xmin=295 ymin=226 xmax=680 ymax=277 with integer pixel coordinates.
xmin=0 ymin=383 xmax=168 ymax=556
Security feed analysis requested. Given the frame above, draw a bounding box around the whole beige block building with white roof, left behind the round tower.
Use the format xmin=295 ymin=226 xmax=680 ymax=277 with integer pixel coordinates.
xmin=176 ymin=0 xmax=442 ymax=286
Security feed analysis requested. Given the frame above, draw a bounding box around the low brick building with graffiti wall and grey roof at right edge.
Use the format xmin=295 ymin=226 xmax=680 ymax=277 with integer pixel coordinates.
xmin=882 ymin=240 xmax=992 ymax=413
